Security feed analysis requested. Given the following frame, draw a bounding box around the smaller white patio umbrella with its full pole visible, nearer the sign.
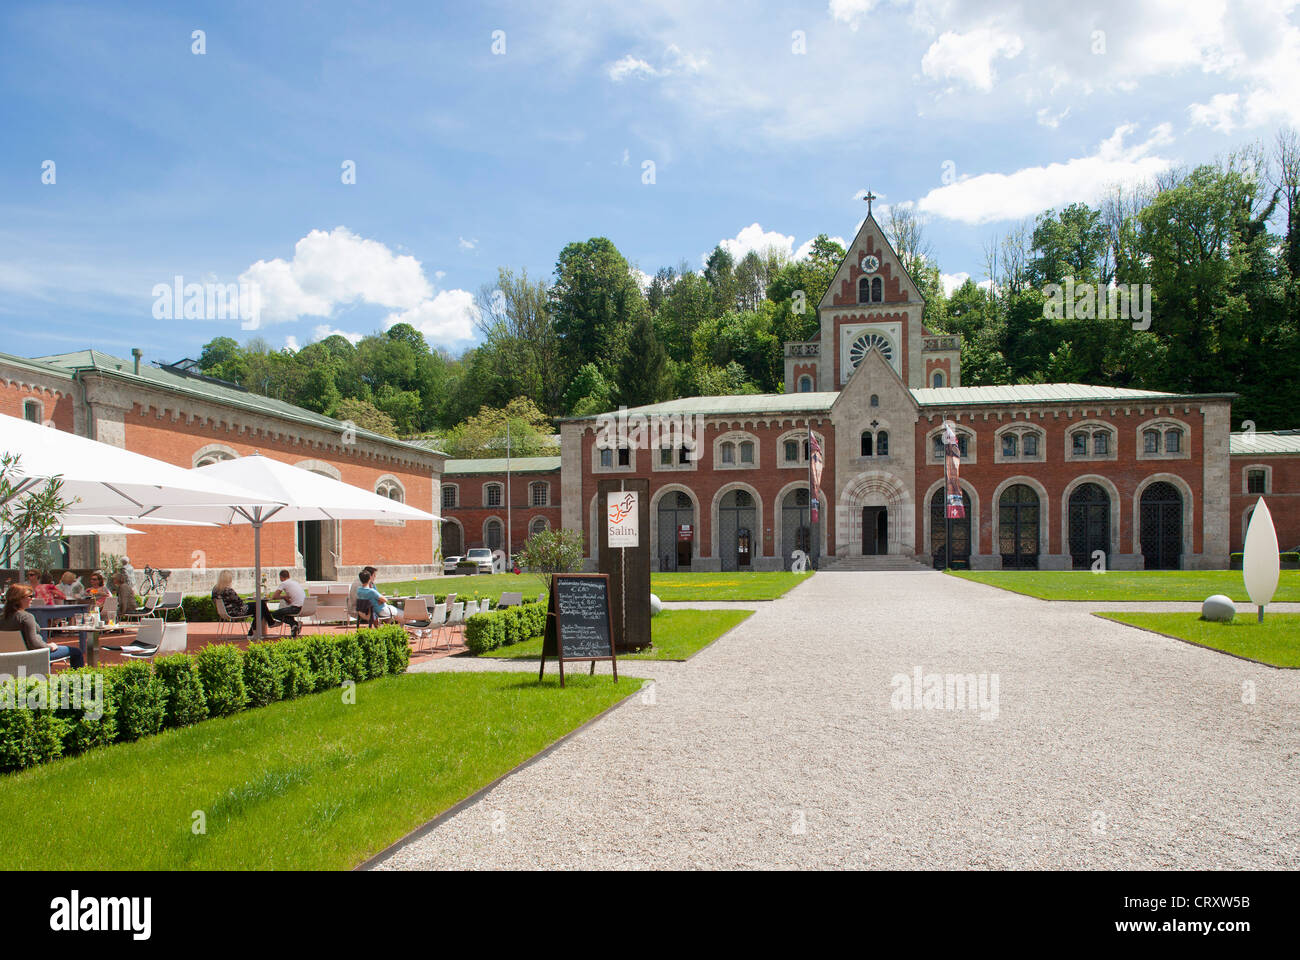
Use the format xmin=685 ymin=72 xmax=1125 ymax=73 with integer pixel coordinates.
xmin=157 ymin=454 xmax=442 ymax=636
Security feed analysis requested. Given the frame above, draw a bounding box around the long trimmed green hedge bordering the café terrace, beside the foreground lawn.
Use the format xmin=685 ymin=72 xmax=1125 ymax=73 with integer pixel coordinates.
xmin=0 ymin=626 xmax=411 ymax=773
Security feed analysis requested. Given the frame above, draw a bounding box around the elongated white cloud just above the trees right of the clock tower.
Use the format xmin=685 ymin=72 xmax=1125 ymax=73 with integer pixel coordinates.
xmin=917 ymin=124 xmax=1173 ymax=224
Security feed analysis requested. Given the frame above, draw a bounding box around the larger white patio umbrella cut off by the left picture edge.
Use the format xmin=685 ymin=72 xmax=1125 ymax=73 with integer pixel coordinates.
xmin=0 ymin=414 xmax=277 ymax=566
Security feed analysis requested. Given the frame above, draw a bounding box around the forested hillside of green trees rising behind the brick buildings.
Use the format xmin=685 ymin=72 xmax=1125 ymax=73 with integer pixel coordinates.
xmin=199 ymin=133 xmax=1300 ymax=442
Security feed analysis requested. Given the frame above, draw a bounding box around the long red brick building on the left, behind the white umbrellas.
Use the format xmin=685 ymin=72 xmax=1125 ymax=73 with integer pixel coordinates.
xmin=0 ymin=350 xmax=446 ymax=592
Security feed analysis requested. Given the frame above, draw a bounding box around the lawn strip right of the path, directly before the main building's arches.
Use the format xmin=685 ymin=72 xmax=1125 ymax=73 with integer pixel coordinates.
xmin=949 ymin=570 xmax=1300 ymax=604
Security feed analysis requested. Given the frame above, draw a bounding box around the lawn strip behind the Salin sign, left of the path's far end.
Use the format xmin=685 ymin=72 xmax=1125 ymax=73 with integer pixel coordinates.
xmin=380 ymin=570 xmax=813 ymax=602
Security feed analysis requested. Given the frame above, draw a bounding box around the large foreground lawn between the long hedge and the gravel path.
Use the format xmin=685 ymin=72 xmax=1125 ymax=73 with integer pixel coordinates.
xmin=0 ymin=673 xmax=641 ymax=870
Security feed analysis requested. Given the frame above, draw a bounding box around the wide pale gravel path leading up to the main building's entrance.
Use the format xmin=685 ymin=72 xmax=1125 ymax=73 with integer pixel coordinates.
xmin=381 ymin=572 xmax=1300 ymax=869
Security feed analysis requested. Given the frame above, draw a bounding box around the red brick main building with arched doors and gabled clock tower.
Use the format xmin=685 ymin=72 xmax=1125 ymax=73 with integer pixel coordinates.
xmin=560 ymin=206 xmax=1300 ymax=570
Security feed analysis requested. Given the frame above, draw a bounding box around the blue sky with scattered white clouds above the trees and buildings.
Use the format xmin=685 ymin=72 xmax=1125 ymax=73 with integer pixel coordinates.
xmin=0 ymin=0 xmax=1300 ymax=360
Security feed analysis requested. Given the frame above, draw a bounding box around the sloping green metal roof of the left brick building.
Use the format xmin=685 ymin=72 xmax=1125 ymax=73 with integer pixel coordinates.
xmin=34 ymin=350 xmax=446 ymax=457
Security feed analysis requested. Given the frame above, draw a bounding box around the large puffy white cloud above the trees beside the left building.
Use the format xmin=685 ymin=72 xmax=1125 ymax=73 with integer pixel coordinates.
xmin=239 ymin=226 xmax=433 ymax=323
